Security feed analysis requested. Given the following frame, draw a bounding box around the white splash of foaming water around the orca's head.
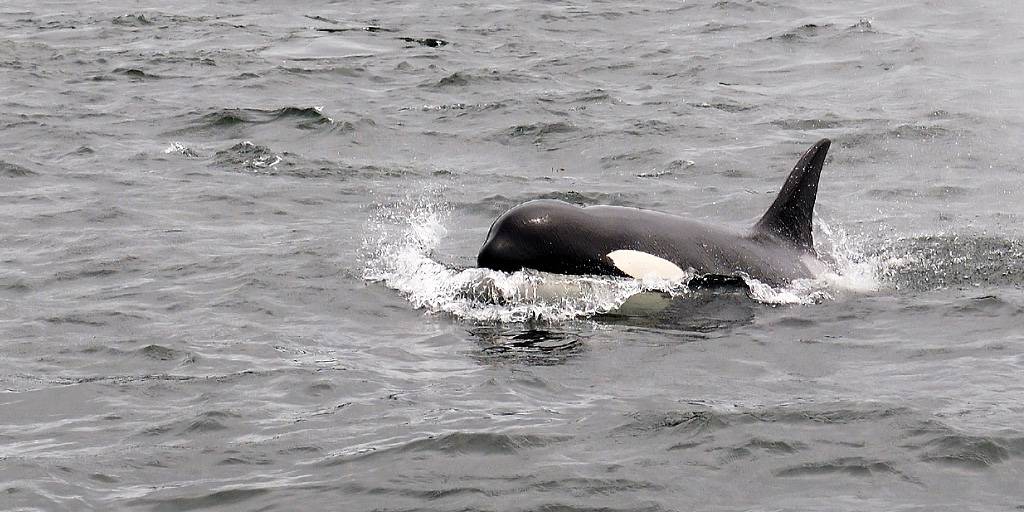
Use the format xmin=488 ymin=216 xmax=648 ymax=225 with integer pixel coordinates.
xmin=362 ymin=193 xmax=686 ymax=322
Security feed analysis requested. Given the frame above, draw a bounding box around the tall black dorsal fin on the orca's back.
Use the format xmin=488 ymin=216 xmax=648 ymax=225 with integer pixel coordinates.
xmin=754 ymin=138 xmax=831 ymax=251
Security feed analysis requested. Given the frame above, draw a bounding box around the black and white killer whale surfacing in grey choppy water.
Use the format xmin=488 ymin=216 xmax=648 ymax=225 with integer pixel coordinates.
xmin=477 ymin=138 xmax=831 ymax=287
